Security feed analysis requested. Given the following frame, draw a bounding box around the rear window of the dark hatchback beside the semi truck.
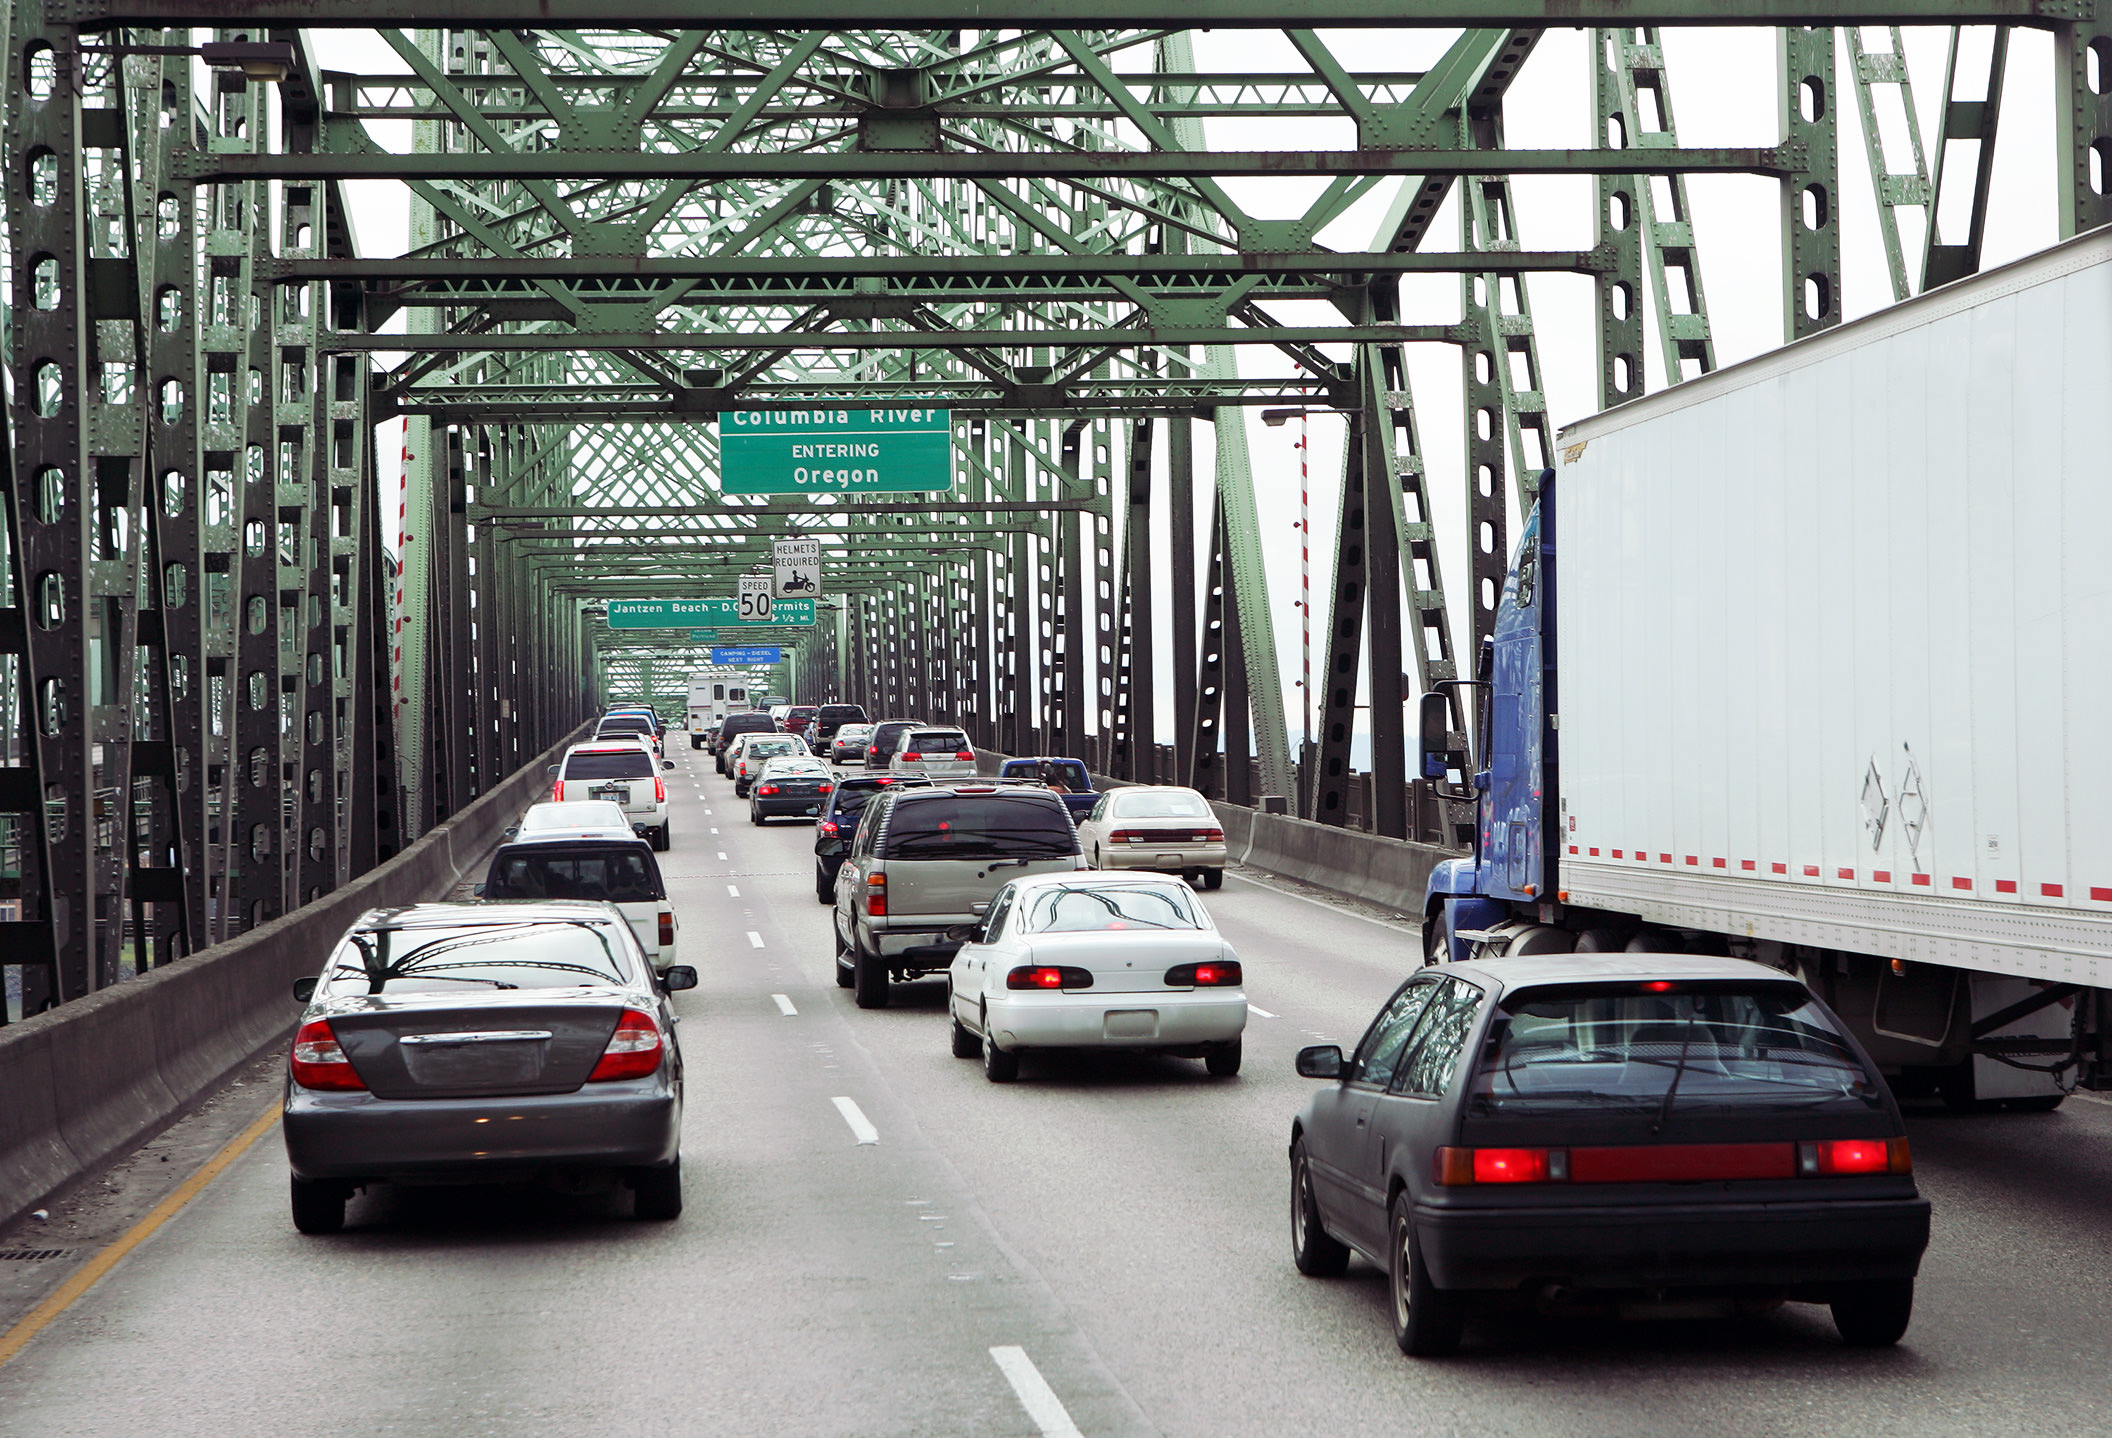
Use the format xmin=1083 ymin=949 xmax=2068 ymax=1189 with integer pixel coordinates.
xmin=1468 ymin=980 xmax=1884 ymax=1123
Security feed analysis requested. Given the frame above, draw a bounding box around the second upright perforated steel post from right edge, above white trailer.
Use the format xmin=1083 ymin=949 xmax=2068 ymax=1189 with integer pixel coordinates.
xmin=1774 ymin=25 xmax=1842 ymax=339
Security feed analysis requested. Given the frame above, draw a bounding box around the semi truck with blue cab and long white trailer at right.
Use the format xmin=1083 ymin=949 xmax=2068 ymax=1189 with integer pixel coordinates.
xmin=1423 ymin=230 xmax=2112 ymax=1106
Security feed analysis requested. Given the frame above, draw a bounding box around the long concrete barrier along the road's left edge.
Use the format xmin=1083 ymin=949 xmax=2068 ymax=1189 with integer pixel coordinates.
xmin=0 ymin=731 xmax=585 ymax=1227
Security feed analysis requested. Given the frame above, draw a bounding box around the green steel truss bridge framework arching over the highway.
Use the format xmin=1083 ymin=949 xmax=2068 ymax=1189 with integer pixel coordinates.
xmin=0 ymin=0 xmax=2112 ymax=1022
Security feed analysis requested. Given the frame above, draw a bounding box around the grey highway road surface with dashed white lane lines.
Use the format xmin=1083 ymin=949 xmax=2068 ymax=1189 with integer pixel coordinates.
xmin=0 ymin=735 xmax=2112 ymax=1438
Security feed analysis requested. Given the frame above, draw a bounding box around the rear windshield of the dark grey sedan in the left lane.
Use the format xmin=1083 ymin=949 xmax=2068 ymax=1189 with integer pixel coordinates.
xmin=327 ymin=919 xmax=629 ymax=995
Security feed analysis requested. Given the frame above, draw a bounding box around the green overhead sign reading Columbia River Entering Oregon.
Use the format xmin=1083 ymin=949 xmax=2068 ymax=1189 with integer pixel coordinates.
xmin=718 ymin=410 xmax=953 ymax=494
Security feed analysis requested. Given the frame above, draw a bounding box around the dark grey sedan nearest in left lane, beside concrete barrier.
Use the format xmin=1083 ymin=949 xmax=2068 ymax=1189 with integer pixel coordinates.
xmin=283 ymin=902 xmax=697 ymax=1233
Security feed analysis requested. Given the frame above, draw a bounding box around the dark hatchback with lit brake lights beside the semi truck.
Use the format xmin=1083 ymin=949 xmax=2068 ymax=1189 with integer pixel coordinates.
xmin=1290 ymin=954 xmax=1928 ymax=1354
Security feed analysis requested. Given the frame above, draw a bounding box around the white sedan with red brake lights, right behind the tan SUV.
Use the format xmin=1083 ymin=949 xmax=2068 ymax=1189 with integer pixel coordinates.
xmin=946 ymin=872 xmax=1246 ymax=1083
